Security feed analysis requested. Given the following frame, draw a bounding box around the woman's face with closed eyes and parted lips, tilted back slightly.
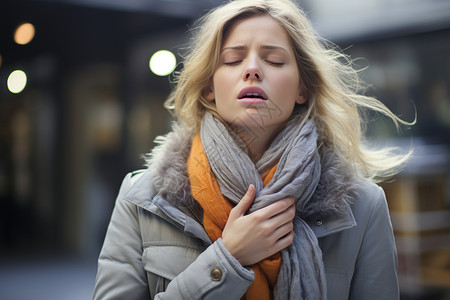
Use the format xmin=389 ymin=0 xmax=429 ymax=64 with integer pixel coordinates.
xmin=206 ymin=16 xmax=306 ymax=136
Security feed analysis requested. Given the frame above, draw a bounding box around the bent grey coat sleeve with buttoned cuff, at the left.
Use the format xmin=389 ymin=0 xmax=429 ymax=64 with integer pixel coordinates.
xmin=93 ymin=175 xmax=254 ymax=300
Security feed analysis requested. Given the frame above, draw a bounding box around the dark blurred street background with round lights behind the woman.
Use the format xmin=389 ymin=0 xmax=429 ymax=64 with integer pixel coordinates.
xmin=0 ymin=0 xmax=450 ymax=300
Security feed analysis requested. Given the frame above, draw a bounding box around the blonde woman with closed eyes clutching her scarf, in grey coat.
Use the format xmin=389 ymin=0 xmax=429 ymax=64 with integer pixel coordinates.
xmin=94 ymin=0 xmax=407 ymax=300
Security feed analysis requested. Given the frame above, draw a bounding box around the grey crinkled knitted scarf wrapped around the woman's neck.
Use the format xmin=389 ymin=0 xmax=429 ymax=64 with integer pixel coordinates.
xmin=200 ymin=113 xmax=326 ymax=300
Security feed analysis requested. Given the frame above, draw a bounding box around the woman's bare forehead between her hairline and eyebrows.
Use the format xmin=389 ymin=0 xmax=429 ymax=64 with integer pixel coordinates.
xmin=223 ymin=15 xmax=290 ymax=46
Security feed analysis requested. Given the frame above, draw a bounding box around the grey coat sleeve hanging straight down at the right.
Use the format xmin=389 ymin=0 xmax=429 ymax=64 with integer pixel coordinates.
xmin=349 ymin=187 xmax=399 ymax=300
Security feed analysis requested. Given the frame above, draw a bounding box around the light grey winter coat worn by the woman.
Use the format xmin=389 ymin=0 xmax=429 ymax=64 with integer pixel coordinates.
xmin=94 ymin=127 xmax=399 ymax=300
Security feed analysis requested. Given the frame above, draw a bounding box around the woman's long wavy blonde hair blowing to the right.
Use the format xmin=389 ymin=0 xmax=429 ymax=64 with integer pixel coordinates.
xmin=166 ymin=0 xmax=414 ymax=181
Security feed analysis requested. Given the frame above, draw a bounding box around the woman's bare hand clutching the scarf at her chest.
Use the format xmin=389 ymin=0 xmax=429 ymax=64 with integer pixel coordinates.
xmin=222 ymin=185 xmax=295 ymax=266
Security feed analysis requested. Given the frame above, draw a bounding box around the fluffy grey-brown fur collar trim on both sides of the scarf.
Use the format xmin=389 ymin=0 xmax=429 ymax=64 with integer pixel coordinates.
xmin=145 ymin=123 xmax=356 ymax=219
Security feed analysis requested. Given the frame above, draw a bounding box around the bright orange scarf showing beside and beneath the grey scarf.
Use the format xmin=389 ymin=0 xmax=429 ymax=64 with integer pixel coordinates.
xmin=187 ymin=134 xmax=281 ymax=300
